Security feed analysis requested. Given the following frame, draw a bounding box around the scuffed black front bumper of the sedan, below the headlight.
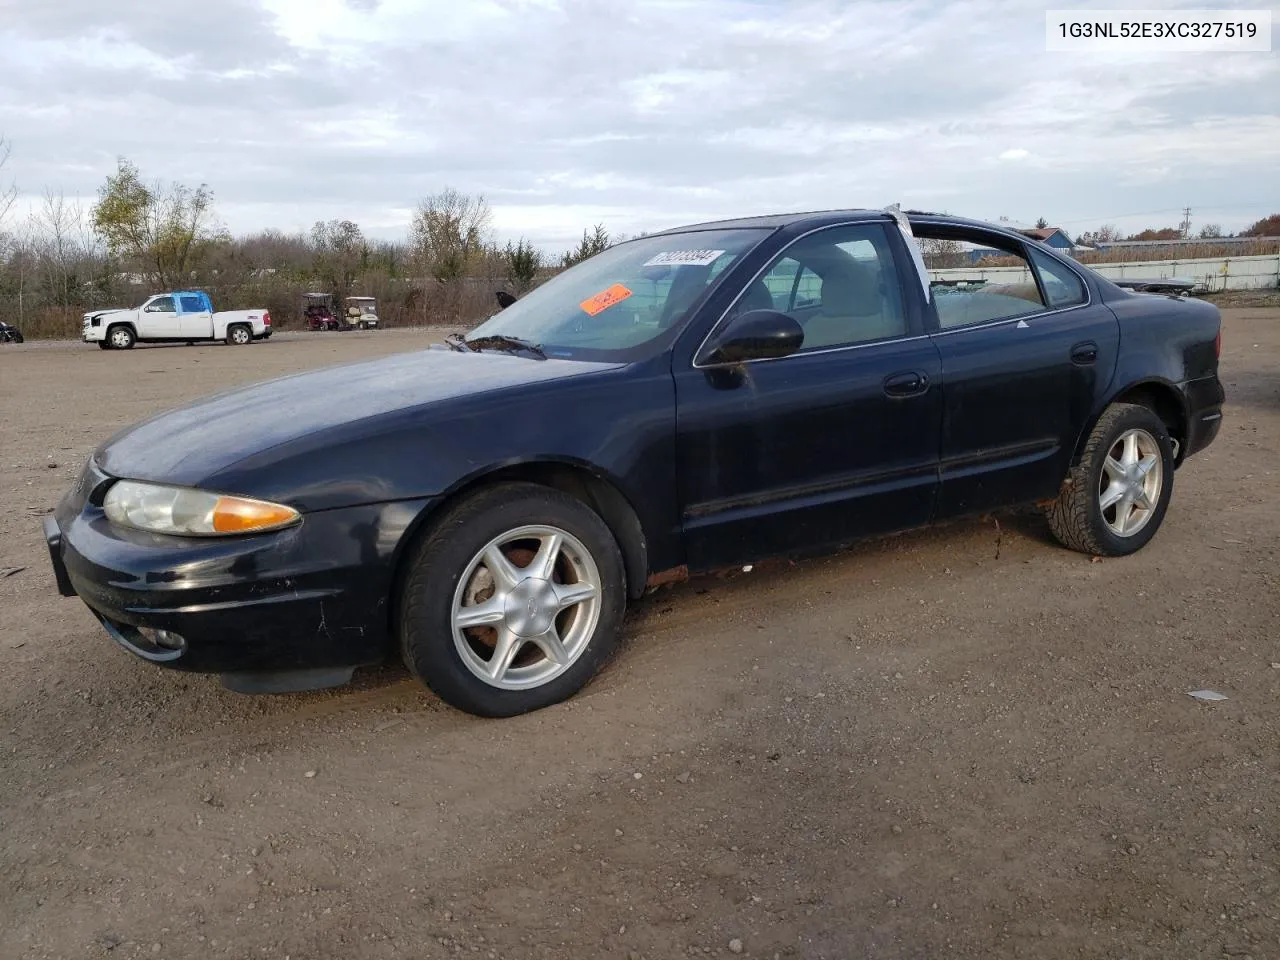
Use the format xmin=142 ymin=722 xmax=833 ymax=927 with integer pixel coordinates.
xmin=45 ymin=484 xmax=429 ymax=689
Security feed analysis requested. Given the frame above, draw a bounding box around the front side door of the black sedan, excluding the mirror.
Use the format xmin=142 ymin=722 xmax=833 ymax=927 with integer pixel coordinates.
xmin=675 ymin=223 xmax=942 ymax=571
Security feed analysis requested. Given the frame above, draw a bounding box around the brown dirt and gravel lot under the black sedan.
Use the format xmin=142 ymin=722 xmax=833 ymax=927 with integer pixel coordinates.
xmin=0 ymin=320 xmax=1280 ymax=960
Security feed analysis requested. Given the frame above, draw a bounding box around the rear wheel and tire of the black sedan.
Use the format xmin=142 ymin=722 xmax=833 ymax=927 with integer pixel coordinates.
xmin=1046 ymin=403 xmax=1174 ymax=557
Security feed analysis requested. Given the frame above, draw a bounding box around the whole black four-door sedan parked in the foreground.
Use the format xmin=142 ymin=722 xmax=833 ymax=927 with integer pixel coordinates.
xmin=45 ymin=210 xmax=1224 ymax=716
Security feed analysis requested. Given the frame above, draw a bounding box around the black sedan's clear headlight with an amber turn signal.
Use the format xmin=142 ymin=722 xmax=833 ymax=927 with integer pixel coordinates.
xmin=102 ymin=480 xmax=301 ymax=536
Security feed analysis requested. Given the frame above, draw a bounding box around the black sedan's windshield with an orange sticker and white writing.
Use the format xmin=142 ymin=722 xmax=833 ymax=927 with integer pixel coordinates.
xmin=467 ymin=229 xmax=769 ymax=361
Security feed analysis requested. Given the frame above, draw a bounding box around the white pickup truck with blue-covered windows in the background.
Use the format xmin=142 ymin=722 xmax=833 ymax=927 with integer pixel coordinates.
xmin=83 ymin=291 xmax=271 ymax=349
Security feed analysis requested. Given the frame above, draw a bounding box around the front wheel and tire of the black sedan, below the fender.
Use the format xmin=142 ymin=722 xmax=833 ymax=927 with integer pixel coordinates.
xmin=399 ymin=484 xmax=626 ymax=717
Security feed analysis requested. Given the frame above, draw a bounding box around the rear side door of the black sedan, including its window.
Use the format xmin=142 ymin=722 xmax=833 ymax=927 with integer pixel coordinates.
xmin=913 ymin=224 xmax=1119 ymax=518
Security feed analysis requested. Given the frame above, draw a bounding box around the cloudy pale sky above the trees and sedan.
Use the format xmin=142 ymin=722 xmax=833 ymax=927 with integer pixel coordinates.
xmin=0 ymin=0 xmax=1280 ymax=250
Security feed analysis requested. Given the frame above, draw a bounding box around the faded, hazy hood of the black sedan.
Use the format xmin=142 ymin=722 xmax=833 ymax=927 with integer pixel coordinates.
xmin=95 ymin=349 xmax=616 ymax=485
